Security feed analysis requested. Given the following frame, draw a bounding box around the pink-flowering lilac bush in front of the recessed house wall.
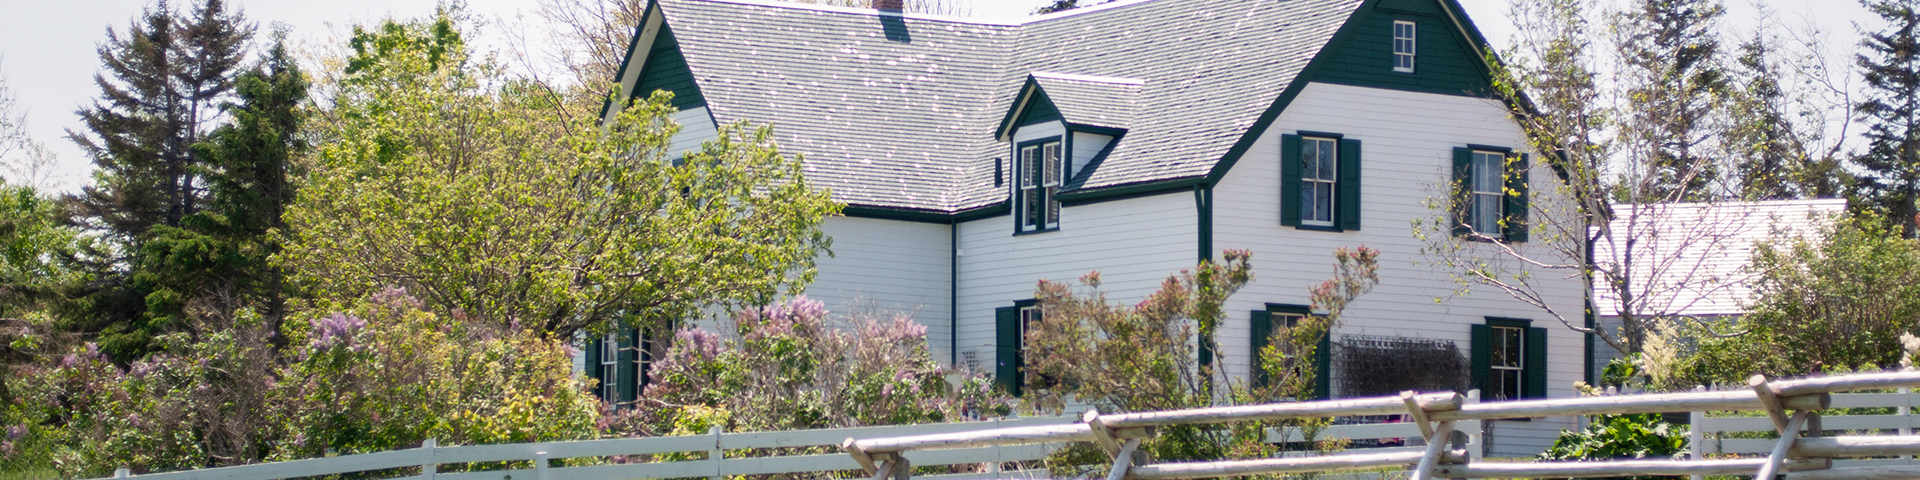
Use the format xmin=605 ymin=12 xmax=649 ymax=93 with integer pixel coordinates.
xmin=629 ymin=298 xmax=1010 ymax=434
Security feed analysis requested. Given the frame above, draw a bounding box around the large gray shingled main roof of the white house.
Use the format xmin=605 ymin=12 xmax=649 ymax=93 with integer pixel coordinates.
xmin=659 ymin=0 xmax=1361 ymax=211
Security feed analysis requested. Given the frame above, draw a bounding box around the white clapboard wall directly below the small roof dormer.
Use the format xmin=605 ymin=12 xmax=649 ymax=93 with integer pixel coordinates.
xmin=958 ymin=192 xmax=1198 ymax=372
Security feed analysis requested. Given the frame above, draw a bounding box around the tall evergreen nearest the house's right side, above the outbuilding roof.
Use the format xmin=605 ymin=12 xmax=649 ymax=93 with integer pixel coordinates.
xmin=1619 ymin=0 xmax=1726 ymax=202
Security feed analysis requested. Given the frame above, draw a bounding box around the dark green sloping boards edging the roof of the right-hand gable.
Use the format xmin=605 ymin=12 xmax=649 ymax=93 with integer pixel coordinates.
xmin=1213 ymin=0 xmax=1530 ymax=185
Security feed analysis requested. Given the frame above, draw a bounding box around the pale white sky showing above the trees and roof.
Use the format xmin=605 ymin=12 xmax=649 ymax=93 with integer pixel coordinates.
xmin=0 ymin=0 xmax=1878 ymax=190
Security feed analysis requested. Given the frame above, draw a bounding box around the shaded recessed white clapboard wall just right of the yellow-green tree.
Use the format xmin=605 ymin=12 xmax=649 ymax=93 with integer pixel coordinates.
xmin=806 ymin=217 xmax=952 ymax=363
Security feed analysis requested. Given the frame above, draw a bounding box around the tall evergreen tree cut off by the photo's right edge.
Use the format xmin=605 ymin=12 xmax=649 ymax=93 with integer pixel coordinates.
xmin=1853 ymin=0 xmax=1920 ymax=238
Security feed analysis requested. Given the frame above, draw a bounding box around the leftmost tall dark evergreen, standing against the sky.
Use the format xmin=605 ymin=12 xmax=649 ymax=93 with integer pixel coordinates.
xmin=63 ymin=0 xmax=253 ymax=361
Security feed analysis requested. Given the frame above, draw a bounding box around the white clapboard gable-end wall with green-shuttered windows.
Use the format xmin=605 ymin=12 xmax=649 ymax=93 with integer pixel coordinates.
xmin=1213 ymin=83 xmax=1584 ymax=455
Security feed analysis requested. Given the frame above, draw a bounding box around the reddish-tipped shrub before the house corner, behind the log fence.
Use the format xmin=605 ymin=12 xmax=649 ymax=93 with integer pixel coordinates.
xmin=1021 ymin=248 xmax=1379 ymax=474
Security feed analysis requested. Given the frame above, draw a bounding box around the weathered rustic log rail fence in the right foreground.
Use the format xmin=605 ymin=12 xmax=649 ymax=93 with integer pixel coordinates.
xmin=843 ymin=372 xmax=1920 ymax=480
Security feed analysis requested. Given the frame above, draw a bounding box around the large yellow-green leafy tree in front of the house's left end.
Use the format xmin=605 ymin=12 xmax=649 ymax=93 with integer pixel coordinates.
xmin=280 ymin=12 xmax=839 ymax=338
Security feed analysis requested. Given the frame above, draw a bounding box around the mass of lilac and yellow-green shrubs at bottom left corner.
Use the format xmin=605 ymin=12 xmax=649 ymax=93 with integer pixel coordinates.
xmin=0 ymin=290 xmax=599 ymax=476
